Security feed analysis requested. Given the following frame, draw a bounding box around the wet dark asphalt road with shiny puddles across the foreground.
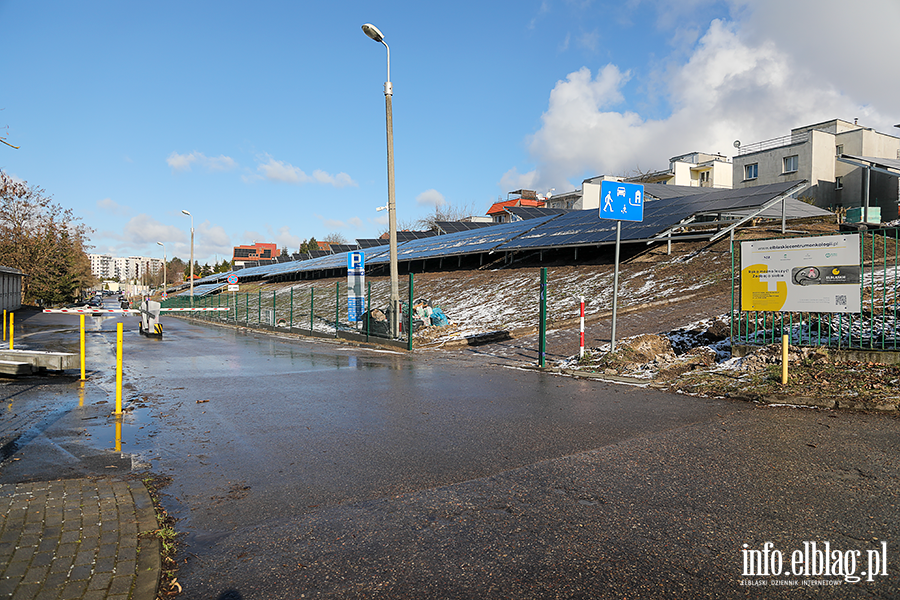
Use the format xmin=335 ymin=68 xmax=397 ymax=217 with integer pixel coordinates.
xmin=0 ymin=308 xmax=900 ymax=599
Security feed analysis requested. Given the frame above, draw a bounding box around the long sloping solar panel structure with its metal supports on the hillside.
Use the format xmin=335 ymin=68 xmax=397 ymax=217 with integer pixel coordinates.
xmin=174 ymin=181 xmax=830 ymax=290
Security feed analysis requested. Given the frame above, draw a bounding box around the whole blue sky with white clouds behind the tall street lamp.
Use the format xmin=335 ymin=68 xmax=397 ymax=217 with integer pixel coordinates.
xmin=0 ymin=0 xmax=900 ymax=263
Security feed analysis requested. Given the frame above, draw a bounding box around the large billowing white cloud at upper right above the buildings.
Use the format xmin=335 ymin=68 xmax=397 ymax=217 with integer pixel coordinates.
xmin=512 ymin=0 xmax=900 ymax=190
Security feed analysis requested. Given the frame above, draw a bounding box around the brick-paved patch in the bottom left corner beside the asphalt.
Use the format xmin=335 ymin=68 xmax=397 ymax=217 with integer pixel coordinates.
xmin=0 ymin=479 xmax=160 ymax=600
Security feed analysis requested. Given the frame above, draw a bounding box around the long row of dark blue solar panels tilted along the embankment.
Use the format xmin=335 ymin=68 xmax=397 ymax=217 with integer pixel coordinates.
xmin=181 ymin=181 xmax=808 ymax=286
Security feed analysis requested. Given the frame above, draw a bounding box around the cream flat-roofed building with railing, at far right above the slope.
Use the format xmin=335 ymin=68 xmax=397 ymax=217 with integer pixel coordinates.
xmin=733 ymin=119 xmax=900 ymax=221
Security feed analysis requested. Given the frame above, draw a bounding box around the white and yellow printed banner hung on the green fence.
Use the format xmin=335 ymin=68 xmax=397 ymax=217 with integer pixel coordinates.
xmin=741 ymin=233 xmax=860 ymax=313
